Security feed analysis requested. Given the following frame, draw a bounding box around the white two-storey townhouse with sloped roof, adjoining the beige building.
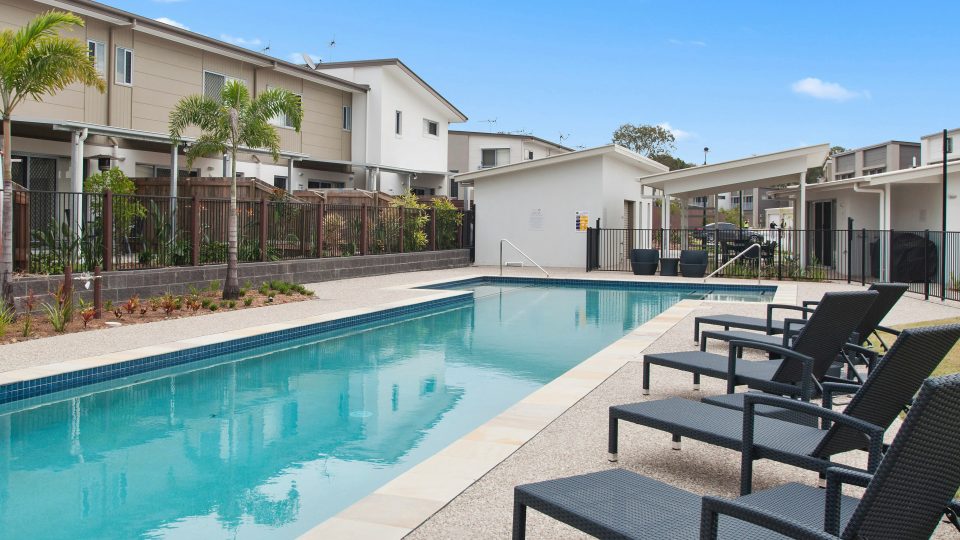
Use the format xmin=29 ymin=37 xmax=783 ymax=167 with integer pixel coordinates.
xmin=316 ymin=58 xmax=467 ymax=196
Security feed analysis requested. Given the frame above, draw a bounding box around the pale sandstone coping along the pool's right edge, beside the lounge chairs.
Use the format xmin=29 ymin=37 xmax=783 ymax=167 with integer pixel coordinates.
xmin=300 ymin=275 xmax=797 ymax=540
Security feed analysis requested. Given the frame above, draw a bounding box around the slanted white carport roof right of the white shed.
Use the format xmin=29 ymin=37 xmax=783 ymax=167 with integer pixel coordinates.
xmin=638 ymin=144 xmax=830 ymax=197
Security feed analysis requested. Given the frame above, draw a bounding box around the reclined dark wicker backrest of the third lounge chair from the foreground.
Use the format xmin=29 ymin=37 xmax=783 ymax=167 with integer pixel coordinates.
xmin=773 ymin=291 xmax=880 ymax=385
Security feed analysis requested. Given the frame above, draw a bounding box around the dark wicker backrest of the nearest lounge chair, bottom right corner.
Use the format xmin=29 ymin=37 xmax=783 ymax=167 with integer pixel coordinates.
xmin=842 ymin=374 xmax=960 ymax=539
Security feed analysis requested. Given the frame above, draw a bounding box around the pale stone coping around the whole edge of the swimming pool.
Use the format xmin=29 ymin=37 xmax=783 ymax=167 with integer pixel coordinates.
xmin=0 ymin=273 xmax=797 ymax=538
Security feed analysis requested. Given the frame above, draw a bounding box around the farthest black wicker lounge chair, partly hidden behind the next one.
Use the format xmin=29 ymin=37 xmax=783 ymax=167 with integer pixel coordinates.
xmin=693 ymin=283 xmax=909 ymax=342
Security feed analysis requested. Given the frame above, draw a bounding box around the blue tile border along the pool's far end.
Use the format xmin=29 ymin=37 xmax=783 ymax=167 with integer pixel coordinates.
xmin=418 ymin=276 xmax=777 ymax=294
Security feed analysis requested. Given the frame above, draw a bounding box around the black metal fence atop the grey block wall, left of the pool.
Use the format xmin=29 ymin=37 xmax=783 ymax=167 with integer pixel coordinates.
xmin=13 ymin=191 xmax=473 ymax=274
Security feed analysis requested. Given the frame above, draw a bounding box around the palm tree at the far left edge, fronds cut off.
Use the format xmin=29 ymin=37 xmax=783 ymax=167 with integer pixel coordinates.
xmin=0 ymin=11 xmax=107 ymax=301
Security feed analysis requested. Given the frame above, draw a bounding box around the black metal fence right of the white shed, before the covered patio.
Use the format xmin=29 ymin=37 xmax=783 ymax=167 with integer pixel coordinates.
xmin=586 ymin=228 xmax=960 ymax=300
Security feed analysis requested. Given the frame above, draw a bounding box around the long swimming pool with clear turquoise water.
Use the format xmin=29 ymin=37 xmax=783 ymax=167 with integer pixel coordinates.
xmin=0 ymin=279 xmax=774 ymax=538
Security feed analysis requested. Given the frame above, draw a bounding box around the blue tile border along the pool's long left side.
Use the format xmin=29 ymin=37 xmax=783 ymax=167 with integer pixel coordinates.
xmin=0 ymin=294 xmax=473 ymax=404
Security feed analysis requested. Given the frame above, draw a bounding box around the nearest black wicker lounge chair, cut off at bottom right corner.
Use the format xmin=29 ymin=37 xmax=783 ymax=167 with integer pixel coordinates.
xmin=513 ymin=375 xmax=960 ymax=540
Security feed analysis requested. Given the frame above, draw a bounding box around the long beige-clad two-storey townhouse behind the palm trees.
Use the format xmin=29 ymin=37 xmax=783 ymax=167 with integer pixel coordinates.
xmin=0 ymin=0 xmax=368 ymax=198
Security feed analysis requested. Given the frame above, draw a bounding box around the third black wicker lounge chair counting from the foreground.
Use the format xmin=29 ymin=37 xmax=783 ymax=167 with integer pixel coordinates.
xmin=643 ymin=291 xmax=879 ymax=399
